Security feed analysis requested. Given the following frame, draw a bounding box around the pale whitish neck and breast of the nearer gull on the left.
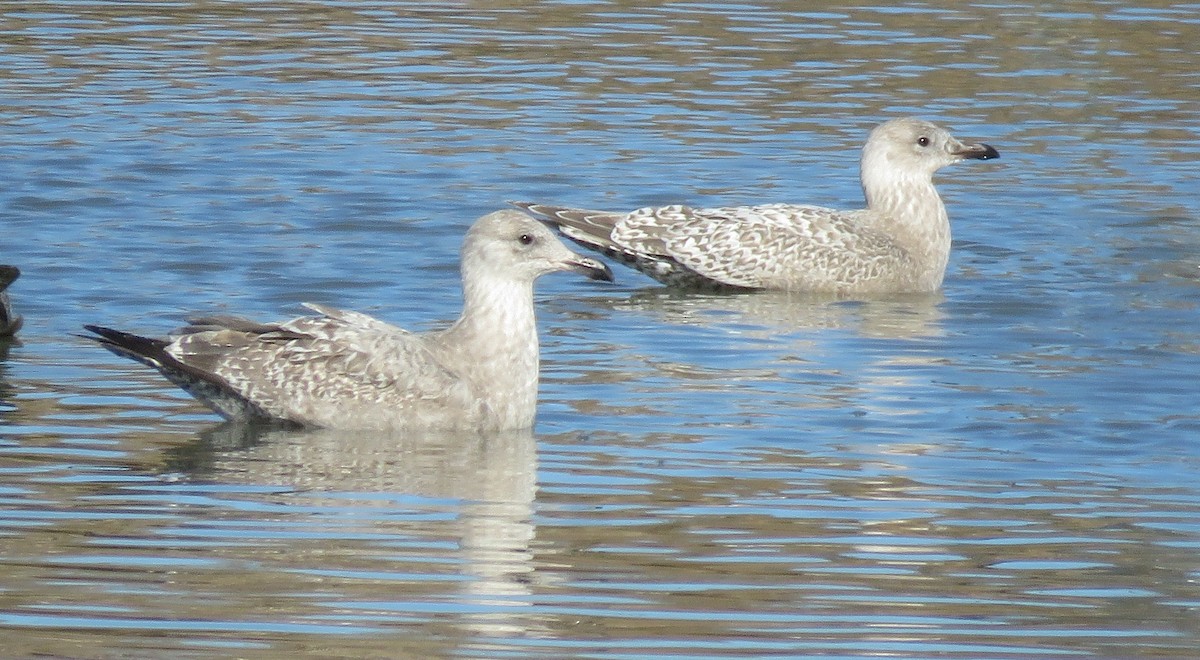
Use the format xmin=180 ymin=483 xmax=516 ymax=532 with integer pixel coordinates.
xmin=442 ymin=272 xmax=539 ymax=428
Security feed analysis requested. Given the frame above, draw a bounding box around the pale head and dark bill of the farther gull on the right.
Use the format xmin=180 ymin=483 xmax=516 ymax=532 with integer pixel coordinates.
xmin=863 ymin=116 xmax=1000 ymax=184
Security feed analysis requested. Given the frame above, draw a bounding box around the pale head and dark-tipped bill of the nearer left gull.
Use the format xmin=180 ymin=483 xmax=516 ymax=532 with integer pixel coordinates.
xmin=462 ymin=210 xmax=612 ymax=282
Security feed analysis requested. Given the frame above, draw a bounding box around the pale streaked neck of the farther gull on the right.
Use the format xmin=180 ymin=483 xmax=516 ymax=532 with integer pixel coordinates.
xmin=862 ymin=156 xmax=950 ymax=289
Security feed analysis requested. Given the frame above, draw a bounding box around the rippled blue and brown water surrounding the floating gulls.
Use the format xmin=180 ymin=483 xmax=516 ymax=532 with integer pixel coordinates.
xmin=0 ymin=0 xmax=1200 ymax=659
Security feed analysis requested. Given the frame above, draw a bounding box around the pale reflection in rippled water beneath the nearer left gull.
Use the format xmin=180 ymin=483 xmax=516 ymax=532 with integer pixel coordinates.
xmin=164 ymin=424 xmax=538 ymax=635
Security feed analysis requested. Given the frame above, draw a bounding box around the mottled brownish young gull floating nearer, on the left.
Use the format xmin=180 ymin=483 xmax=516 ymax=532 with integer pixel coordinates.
xmin=84 ymin=211 xmax=612 ymax=431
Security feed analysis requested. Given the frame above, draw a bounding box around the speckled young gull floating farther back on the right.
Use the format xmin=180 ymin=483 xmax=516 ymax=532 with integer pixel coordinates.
xmin=512 ymin=118 xmax=1000 ymax=294
